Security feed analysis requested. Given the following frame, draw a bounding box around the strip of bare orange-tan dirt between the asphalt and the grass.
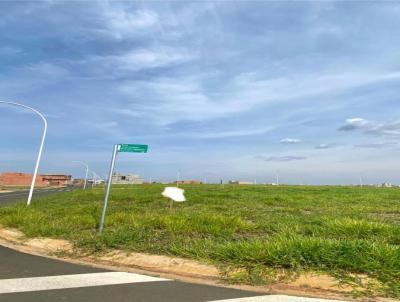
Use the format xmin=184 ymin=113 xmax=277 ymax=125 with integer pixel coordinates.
xmin=0 ymin=226 xmax=398 ymax=302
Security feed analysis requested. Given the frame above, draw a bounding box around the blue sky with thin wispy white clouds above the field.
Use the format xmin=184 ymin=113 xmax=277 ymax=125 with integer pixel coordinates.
xmin=0 ymin=1 xmax=400 ymax=184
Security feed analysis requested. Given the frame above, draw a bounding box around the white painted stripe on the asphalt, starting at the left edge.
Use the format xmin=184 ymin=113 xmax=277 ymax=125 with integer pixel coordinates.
xmin=0 ymin=272 xmax=168 ymax=294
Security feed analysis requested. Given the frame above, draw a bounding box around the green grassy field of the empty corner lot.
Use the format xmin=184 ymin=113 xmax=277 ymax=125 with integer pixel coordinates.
xmin=0 ymin=185 xmax=400 ymax=297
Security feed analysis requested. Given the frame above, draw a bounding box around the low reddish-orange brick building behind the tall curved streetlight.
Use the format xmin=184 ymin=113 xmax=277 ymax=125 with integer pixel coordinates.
xmin=0 ymin=172 xmax=71 ymax=187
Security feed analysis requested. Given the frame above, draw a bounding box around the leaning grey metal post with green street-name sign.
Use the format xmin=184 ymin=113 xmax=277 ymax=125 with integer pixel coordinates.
xmin=99 ymin=144 xmax=149 ymax=235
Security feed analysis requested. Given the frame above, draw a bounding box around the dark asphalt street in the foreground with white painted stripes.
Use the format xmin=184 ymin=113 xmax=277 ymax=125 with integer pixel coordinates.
xmin=0 ymin=246 xmax=346 ymax=302
